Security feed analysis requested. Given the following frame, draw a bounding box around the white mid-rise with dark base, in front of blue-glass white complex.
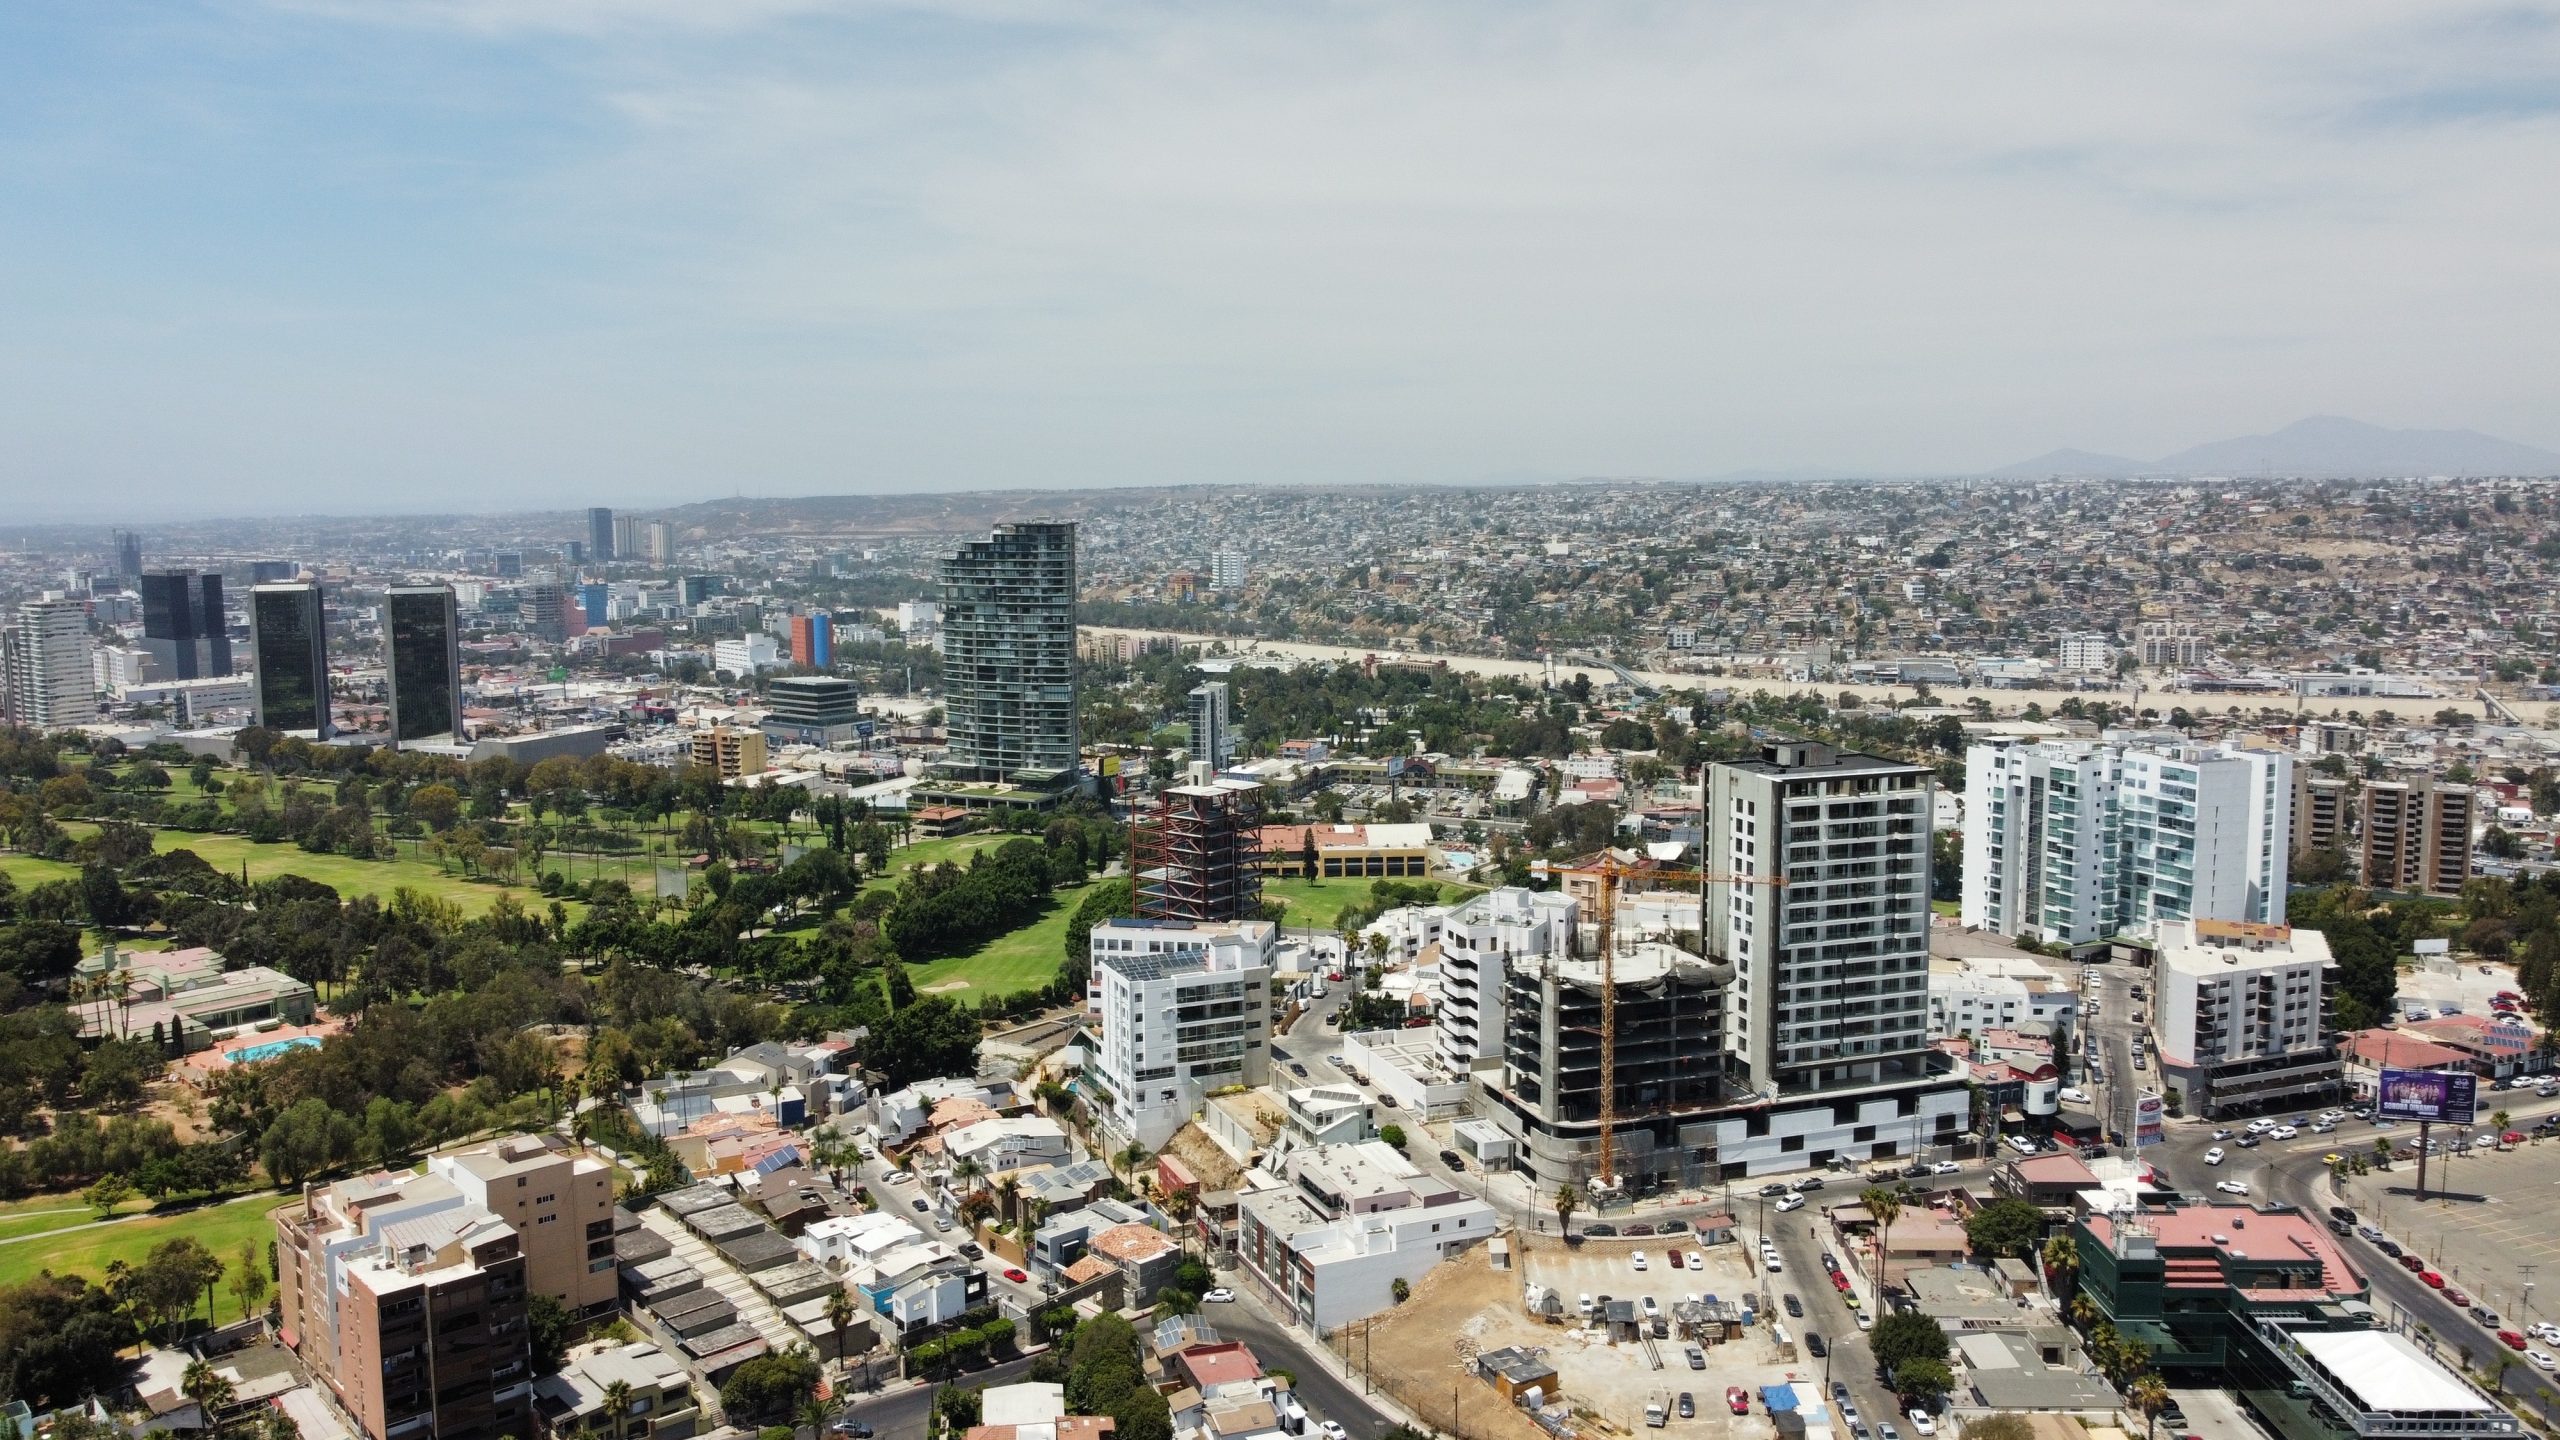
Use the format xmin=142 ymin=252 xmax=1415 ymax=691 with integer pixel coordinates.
xmin=2150 ymin=920 xmax=2345 ymax=1117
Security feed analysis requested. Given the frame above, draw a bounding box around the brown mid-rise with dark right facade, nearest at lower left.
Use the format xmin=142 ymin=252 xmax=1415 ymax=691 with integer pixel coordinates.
xmin=274 ymin=1171 xmax=532 ymax=1440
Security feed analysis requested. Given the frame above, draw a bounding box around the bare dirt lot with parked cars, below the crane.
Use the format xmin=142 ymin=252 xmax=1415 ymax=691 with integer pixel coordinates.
xmin=1352 ymin=1235 xmax=1820 ymax=1440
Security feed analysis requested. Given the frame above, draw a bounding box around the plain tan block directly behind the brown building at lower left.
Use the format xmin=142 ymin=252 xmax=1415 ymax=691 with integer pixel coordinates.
xmin=428 ymin=1133 xmax=617 ymax=1317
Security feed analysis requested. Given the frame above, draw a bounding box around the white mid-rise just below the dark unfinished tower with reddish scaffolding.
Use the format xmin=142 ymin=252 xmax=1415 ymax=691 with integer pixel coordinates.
xmin=1085 ymin=920 xmax=1280 ymax=1150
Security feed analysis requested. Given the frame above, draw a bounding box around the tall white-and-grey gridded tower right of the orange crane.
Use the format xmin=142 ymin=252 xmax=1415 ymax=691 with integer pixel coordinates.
xmin=1705 ymin=740 xmax=1930 ymax=1097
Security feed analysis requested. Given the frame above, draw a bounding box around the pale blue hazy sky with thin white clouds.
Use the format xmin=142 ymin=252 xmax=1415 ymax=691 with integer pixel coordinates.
xmin=0 ymin=0 xmax=2560 ymax=520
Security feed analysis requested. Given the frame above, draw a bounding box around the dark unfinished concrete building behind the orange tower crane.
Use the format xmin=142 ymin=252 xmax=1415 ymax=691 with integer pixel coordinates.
xmin=1485 ymin=940 xmax=1733 ymax=1191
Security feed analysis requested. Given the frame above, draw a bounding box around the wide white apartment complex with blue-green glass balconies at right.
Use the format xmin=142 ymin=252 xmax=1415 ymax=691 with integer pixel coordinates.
xmin=1958 ymin=738 xmax=2294 ymax=945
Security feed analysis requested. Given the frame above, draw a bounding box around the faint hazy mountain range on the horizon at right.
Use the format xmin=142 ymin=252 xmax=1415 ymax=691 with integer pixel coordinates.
xmin=1992 ymin=415 xmax=2560 ymax=479
